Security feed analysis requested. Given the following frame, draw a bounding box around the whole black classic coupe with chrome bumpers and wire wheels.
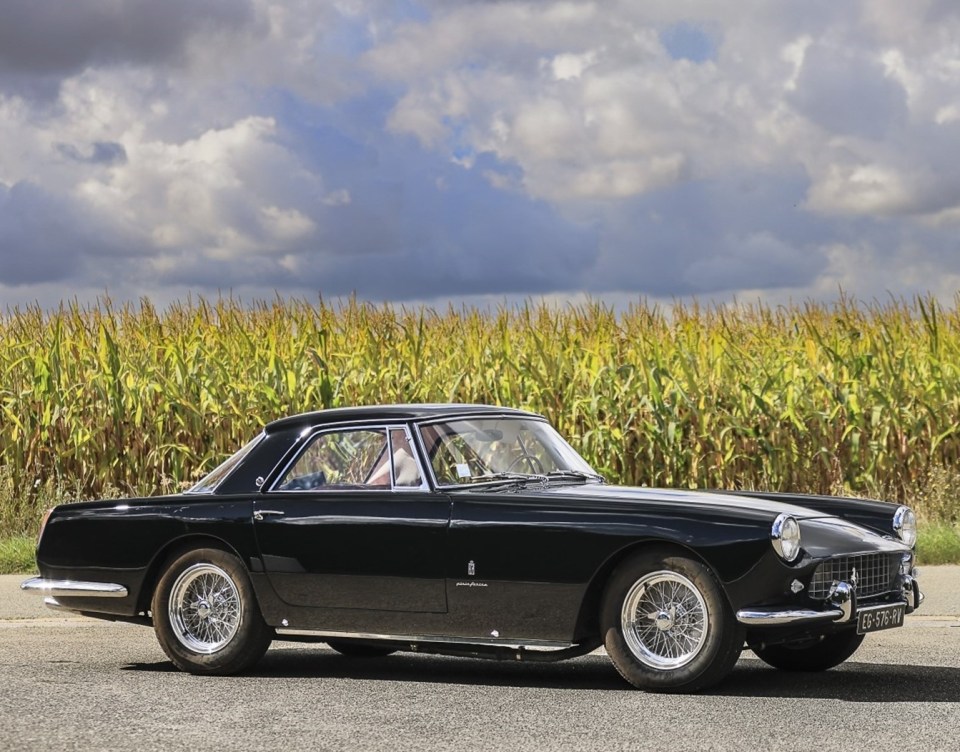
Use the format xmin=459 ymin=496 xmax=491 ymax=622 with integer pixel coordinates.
xmin=22 ymin=405 xmax=923 ymax=692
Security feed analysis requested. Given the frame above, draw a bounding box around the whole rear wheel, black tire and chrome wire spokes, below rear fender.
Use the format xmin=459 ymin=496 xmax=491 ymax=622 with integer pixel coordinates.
xmin=152 ymin=548 xmax=273 ymax=676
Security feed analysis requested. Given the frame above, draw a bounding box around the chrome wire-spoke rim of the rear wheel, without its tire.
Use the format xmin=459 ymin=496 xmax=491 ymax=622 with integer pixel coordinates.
xmin=168 ymin=562 xmax=241 ymax=655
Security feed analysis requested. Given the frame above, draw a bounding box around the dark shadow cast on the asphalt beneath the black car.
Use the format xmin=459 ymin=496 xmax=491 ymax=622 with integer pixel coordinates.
xmin=124 ymin=648 xmax=960 ymax=703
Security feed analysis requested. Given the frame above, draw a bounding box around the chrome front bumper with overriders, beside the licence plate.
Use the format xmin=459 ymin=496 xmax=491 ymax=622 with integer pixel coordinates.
xmin=737 ymin=570 xmax=923 ymax=628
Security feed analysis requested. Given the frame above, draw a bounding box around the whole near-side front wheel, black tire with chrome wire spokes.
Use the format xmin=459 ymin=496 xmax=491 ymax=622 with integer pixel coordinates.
xmin=600 ymin=551 xmax=744 ymax=692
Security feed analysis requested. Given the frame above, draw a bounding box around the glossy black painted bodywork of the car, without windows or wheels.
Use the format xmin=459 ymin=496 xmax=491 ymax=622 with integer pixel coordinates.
xmin=37 ymin=405 xmax=908 ymax=642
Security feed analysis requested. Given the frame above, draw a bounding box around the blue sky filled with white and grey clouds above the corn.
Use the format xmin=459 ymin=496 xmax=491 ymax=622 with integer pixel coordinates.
xmin=0 ymin=0 xmax=960 ymax=311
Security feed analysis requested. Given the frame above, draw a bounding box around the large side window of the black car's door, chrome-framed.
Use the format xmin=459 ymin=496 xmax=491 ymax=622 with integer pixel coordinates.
xmin=277 ymin=429 xmax=390 ymax=491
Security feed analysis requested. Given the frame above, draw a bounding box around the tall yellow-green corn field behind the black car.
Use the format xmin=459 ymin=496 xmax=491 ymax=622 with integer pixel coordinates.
xmin=0 ymin=298 xmax=960 ymax=534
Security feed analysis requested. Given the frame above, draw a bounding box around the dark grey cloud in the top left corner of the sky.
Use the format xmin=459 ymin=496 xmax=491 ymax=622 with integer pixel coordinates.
xmin=0 ymin=0 xmax=253 ymax=82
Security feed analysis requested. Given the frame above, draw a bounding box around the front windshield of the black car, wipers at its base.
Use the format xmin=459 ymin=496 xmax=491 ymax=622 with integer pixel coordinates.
xmin=420 ymin=418 xmax=601 ymax=486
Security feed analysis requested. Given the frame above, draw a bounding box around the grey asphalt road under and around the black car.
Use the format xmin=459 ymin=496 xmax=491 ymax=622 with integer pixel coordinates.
xmin=0 ymin=567 xmax=960 ymax=752
